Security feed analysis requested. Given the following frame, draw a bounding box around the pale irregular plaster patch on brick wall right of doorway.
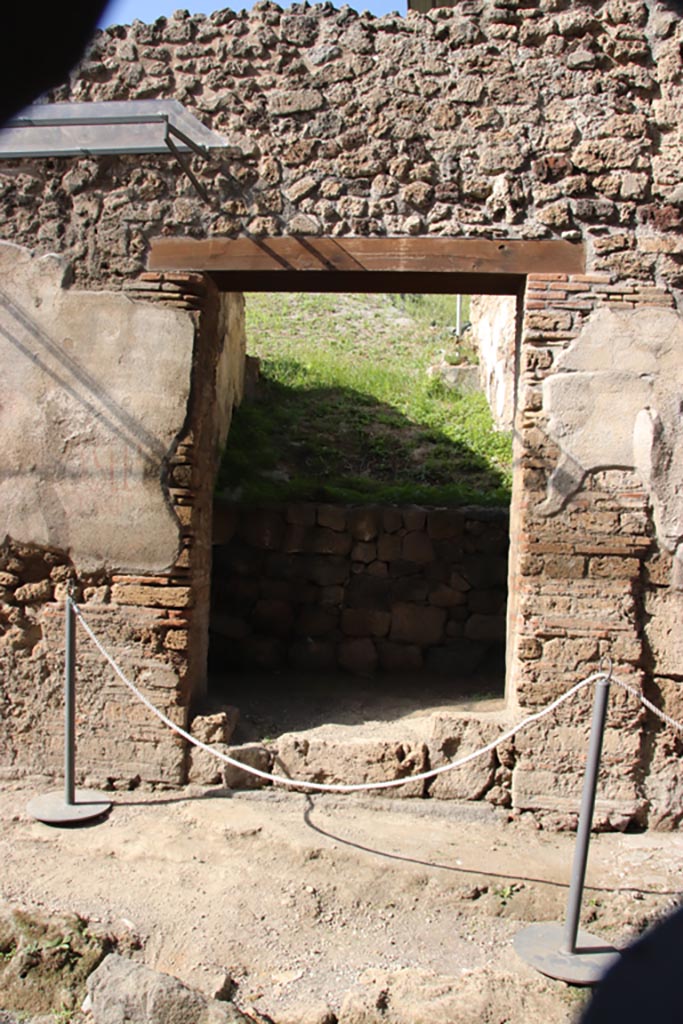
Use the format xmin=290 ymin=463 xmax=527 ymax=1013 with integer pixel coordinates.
xmin=537 ymin=307 xmax=683 ymax=585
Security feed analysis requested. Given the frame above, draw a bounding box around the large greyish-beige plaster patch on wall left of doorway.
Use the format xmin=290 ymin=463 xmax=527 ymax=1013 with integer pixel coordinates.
xmin=0 ymin=243 xmax=195 ymax=571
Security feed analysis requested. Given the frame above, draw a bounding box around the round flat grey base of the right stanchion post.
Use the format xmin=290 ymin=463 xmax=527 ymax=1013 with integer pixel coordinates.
xmin=513 ymin=924 xmax=620 ymax=985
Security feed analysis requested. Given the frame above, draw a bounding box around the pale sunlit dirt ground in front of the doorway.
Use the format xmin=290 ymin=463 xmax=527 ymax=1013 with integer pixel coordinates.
xmin=0 ymin=779 xmax=683 ymax=1024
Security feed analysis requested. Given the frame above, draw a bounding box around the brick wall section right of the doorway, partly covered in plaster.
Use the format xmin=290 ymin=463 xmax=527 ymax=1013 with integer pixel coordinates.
xmin=508 ymin=274 xmax=682 ymax=826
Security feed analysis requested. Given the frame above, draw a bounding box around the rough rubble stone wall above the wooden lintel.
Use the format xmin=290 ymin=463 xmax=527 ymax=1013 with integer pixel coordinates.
xmin=0 ymin=0 xmax=683 ymax=287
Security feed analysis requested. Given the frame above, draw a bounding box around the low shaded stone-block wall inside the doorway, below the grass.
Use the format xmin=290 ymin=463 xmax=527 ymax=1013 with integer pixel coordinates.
xmin=211 ymin=504 xmax=508 ymax=677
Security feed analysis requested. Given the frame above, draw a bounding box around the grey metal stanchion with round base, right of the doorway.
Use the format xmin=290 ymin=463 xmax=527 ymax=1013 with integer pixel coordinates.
xmin=514 ymin=663 xmax=618 ymax=985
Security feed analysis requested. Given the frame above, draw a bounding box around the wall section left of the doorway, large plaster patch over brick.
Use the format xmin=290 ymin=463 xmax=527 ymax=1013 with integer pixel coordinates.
xmin=0 ymin=258 xmax=244 ymax=784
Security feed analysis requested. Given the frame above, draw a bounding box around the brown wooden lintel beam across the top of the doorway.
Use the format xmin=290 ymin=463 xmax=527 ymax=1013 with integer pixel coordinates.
xmin=148 ymin=236 xmax=586 ymax=278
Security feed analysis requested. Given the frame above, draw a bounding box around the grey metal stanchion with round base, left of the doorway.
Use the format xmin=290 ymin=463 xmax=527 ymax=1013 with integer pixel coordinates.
xmin=27 ymin=594 xmax=112 ymax=825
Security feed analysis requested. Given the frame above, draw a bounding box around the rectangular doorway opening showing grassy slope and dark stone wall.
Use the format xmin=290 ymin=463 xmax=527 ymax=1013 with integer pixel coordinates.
xmin=203 ymin=279 xmax=519 ymax=742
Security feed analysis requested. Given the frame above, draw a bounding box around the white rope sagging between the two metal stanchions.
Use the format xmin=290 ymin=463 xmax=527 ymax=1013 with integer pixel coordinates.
xmin=68 ymin=597 xmax=683 ymax=793
